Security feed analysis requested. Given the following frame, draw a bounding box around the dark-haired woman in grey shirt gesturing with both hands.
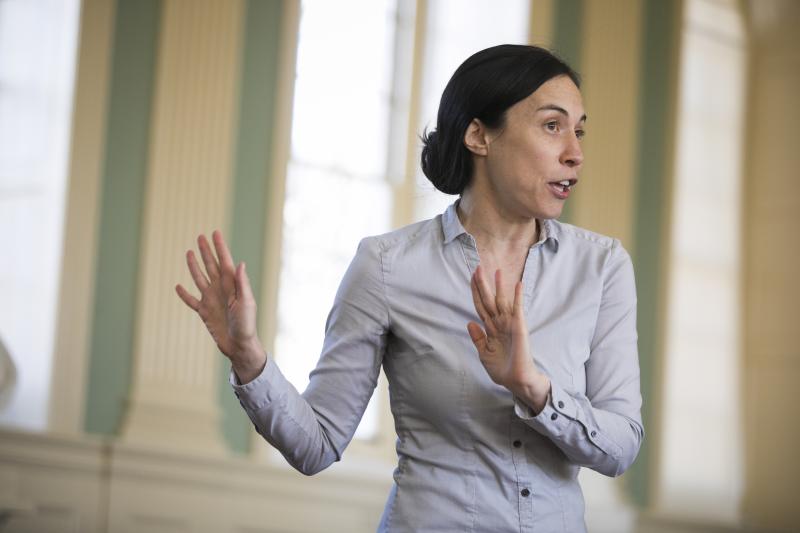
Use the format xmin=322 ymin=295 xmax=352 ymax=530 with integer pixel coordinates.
xmin=177 ymin=45 xmax=643 ymax=532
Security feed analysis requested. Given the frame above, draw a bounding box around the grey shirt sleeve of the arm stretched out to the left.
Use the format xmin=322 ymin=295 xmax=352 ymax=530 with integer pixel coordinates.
xmin=230 ymin=237 xmax=389 ymax=475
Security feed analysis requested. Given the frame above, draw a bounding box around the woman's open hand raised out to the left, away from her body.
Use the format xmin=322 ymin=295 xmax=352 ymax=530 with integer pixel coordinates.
xmin=175 ymin=231 xmax=267 ymax=383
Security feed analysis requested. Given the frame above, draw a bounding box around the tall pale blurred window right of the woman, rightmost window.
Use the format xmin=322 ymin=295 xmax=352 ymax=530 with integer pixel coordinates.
xmin=659 ymin=0 xmax=745 ymax=523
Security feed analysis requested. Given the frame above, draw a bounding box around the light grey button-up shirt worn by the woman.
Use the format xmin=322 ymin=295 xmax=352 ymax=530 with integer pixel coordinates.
xmin=231 ymin=198 xmax=644 ymax=533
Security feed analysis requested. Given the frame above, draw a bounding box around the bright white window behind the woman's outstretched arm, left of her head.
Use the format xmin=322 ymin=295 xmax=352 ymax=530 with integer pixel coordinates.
xmin=275 ymin=0 xmax=396 ymax=438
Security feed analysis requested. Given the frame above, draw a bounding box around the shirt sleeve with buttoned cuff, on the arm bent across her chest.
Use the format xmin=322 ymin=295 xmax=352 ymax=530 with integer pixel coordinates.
xmin=514 ymin=240 xmax=644 ymax=476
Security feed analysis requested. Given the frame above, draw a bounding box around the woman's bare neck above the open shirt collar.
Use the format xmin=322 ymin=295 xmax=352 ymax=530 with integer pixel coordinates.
xmin=456 ymin=187 xmax=539 ymax=250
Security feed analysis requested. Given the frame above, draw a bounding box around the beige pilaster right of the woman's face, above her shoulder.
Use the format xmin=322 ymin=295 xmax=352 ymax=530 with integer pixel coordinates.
xmin=572 ymin=0 xmax=643 ymax=251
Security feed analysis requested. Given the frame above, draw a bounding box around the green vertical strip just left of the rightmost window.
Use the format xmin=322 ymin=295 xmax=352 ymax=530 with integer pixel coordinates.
xmin=626 ymin=0 xmax=681 ymax=507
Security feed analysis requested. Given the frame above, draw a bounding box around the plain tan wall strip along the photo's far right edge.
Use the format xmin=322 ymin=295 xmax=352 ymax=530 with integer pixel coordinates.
xmin=742 ymin=0 xmax=800 ymax=531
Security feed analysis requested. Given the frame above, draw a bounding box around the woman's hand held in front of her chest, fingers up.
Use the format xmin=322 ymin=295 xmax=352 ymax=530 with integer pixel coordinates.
xmin=467 ymin=265 xmax=550 ymax=412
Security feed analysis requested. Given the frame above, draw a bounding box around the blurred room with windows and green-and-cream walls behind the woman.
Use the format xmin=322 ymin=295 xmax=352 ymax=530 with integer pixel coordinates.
xmin=0 ymin=0 xmax=800 ymax=533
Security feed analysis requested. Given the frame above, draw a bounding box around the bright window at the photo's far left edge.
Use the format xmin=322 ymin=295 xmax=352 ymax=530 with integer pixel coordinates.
xmin=0 ymin=0 xmax=80 ymax=429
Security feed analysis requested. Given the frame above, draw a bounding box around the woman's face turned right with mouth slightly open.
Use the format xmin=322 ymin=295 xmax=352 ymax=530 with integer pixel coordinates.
xmin=478 ymin=76 xmax=586 ymax=218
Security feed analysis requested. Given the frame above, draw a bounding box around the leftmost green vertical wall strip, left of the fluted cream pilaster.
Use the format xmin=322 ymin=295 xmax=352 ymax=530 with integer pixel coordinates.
xmin=84 ymin=0 xmax=161 ymax=434
